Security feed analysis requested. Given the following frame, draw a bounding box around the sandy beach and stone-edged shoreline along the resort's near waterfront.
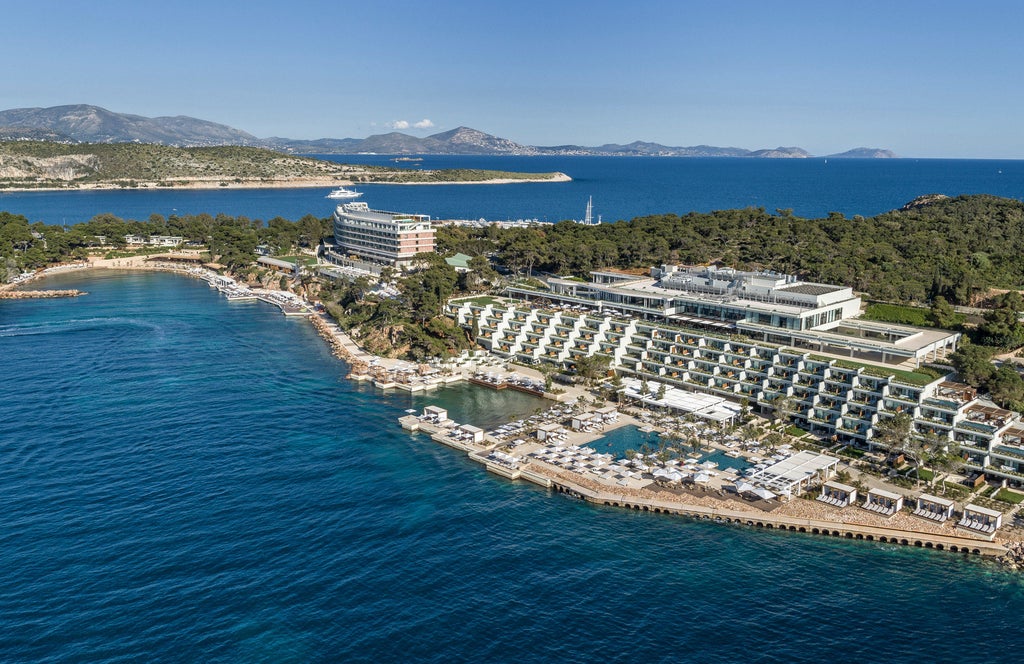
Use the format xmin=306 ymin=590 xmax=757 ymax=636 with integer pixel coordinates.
xmin=9 ymin=256 xmax=1021 ymax=569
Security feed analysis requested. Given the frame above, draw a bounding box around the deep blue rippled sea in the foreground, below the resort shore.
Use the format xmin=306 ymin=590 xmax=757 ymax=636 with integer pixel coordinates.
xmin=0 ymin=274 xmax=1024 ymax=663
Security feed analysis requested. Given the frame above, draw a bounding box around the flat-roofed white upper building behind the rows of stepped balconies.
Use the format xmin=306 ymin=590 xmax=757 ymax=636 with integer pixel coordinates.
xmin=509 ymin=265 xmax=959 ymax=367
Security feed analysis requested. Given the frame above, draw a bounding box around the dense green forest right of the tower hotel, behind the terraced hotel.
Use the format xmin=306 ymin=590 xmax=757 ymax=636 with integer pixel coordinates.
xmin=438 ymin=191 xmax=1024 ymax=304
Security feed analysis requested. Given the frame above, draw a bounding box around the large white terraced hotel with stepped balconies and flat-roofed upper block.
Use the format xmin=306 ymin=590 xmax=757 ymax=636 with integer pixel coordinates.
xmin=451 ymin=267 xmax=1024 ymax=484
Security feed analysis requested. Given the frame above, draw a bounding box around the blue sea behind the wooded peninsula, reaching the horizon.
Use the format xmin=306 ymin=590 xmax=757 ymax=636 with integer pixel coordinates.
xmin=0 ymin=155 xmax=1024 ymax=223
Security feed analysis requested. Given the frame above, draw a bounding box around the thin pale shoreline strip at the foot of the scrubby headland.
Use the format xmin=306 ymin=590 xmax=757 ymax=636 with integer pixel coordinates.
xmin=0 ymin=172 xmax=572 ymax=191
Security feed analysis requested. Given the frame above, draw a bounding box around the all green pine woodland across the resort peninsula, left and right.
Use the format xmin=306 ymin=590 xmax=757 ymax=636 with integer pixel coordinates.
xmin=6 ymin=191 xmax=1024 ymax=372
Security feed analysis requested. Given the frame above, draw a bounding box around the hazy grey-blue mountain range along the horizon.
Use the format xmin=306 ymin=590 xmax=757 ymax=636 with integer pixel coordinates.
xmin=0 ymin=105 xmax=896 ymax=159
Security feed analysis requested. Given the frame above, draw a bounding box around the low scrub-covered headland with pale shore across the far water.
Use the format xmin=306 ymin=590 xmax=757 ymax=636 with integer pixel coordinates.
xmin=0 ymin=139 xmax=570 ymax=191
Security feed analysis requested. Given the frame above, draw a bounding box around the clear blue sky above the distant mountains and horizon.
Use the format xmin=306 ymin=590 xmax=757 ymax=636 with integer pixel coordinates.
xmin=8 ymin=0 xmax=1024 ymax=158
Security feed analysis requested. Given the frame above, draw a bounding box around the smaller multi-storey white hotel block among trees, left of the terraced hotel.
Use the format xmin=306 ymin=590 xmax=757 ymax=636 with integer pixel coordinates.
xmin=333 ymin=202 xmax=434 ymax=266
